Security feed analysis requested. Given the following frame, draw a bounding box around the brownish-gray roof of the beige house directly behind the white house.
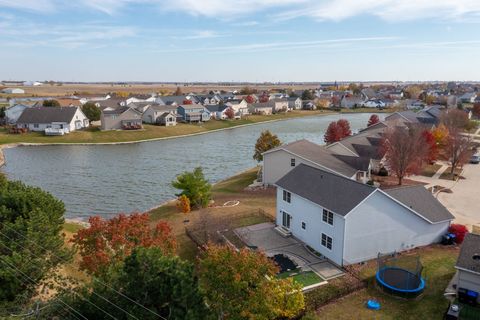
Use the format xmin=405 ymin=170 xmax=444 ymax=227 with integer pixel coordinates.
xmin=271 ymin=139 xmax=358 ymax=177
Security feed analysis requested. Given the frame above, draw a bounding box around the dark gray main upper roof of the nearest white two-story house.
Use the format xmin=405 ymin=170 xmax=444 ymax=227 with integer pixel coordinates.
xmin=276 ymin=164 xmax=376 ymax=216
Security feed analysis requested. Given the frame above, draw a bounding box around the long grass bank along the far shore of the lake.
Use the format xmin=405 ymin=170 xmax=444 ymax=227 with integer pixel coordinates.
xmin=0 ymin=110 xmax=333 ymax=145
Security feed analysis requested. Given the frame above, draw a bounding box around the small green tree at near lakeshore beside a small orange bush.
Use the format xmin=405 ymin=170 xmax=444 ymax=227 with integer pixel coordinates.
xmin=172 ymin=167 xmax=212 ymax=208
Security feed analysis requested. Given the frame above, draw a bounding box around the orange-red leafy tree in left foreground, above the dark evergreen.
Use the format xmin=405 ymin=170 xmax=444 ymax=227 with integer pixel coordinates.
xmin=71 ymin=213 xmax=176 ymax=276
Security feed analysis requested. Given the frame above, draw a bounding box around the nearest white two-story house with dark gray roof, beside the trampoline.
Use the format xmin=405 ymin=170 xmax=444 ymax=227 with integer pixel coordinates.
xmin=275 ymin=164 xmax=454 ymax=266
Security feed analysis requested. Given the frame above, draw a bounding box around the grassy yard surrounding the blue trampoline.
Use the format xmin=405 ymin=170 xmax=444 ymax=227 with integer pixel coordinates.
xmin=317 ymin=245 xmax=458 ymax=319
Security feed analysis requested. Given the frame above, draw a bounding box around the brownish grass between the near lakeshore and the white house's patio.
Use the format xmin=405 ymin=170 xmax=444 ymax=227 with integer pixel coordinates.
xmin=150 ymin=168 xmax=275 ymax=260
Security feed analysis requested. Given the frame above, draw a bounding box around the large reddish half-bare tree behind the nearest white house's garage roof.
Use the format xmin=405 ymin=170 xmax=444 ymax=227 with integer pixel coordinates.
xmin=382 ymin=126 xmax=429 ymax=185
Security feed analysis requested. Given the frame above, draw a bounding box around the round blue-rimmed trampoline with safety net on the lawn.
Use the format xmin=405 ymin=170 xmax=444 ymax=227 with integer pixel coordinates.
xmin=375 ymin=256 xmax=425 ymax=298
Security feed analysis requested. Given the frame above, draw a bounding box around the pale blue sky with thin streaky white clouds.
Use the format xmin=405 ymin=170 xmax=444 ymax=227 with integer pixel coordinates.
xmin=0 ymin=0 xmax=480 ymax=82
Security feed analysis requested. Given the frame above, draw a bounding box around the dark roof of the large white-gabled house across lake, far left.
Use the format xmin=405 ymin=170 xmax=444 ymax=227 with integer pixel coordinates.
xmin=17 ymin=107 xmax=78 ymax=123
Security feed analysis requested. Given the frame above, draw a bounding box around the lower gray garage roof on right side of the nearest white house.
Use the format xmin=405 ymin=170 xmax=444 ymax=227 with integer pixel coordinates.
xmin=384 ymin=185 xmax=454 ymax=223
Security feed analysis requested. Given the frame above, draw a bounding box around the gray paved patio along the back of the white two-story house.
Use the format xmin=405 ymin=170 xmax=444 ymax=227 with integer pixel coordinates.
xmin=234 ymin=223 xmax=344 ymax=280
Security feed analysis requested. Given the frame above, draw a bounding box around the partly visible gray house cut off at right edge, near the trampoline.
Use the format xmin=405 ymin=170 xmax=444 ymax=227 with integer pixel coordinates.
xmin=455 ymin=233 xmax=480 ymax=303
